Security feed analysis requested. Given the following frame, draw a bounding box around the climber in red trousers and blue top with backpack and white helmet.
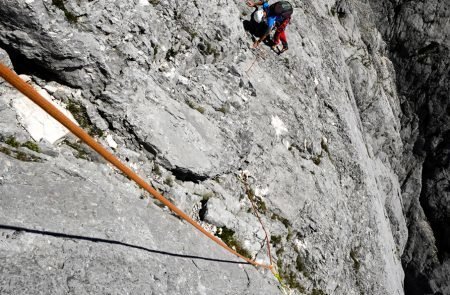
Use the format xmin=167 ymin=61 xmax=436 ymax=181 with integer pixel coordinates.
xmin=247 ymin=0 xmax=293 ymax=54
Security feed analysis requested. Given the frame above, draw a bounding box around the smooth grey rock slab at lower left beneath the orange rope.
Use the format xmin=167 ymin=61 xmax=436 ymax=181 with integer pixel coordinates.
xmin=0 ymin=154 xmax=277 ymax=294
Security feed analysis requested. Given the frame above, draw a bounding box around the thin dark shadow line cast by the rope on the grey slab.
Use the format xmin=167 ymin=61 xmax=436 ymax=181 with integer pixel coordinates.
xmin=0 ymin=224 xmax=250 ymax=264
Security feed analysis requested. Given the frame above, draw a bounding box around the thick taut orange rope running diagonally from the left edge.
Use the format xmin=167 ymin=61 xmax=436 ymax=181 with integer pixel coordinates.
xmin=0 ymin=63 xmax=272 ymax=269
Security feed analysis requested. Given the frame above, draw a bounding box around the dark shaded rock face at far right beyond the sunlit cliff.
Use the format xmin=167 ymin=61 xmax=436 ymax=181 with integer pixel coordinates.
xmin=366 ymin=1 xmax=450 ymax=294
